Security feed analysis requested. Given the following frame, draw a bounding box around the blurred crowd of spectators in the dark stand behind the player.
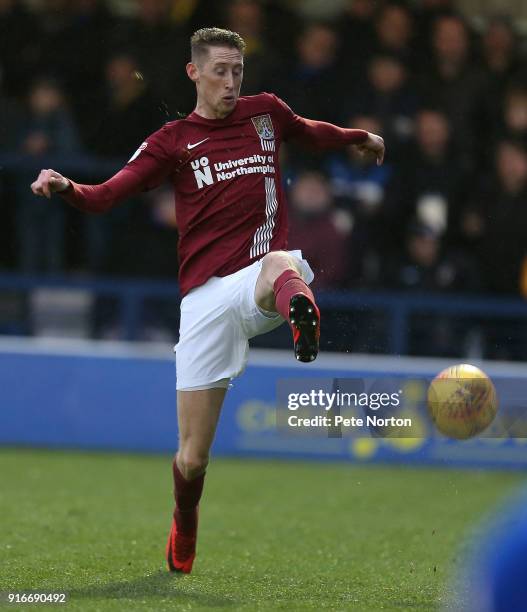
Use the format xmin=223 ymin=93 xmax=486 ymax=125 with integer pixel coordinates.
xmin=0 ymin=0 xmax=527 ymax=304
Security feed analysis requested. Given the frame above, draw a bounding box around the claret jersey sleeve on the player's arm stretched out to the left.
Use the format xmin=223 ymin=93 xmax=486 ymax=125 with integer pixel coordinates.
xmin=59 ymin=126 xmax=189 ymax=213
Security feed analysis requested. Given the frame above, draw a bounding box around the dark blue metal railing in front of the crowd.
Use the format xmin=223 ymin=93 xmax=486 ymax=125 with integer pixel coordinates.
xmin=0 ymin=273 xmax=527 ymax=355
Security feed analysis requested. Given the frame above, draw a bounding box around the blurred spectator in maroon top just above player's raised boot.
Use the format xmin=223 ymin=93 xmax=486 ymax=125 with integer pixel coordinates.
xmin=289 ymin=172 xmax=351 ymax=289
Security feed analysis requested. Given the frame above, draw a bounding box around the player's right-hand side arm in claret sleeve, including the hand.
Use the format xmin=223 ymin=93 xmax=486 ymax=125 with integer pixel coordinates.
xmin=273 ymin=96 xmax=385 ymax=166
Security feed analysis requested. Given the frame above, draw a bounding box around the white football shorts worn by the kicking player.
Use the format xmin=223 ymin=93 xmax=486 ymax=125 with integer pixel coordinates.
xmin=174 ymin=251 xmax=314 ymax=390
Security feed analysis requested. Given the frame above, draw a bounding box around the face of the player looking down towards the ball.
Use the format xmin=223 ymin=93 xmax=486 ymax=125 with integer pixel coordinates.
xmin=193 ymin=47 xmax=243 ymax=119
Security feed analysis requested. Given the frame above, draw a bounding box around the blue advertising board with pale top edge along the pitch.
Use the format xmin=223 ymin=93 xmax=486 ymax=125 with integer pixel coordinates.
xmin=0 ymin=338 xmax=527 ymax=468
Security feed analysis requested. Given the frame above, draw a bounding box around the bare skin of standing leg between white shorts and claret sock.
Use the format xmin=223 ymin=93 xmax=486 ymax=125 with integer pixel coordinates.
xmin=177 ymin=387 xmax=226 ymax=457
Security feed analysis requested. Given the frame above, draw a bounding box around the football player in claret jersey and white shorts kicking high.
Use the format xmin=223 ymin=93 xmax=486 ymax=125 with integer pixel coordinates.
xmin=31 ymin=28 xmax=384 ymax=573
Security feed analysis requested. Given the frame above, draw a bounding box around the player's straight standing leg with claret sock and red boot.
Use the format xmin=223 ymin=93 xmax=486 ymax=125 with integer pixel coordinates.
xmin=167 ymin=388 xmax=228 ymax=573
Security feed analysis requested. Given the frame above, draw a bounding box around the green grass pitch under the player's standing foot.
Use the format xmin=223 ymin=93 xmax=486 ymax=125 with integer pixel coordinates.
xmin=0 ymin=450 xmax=523 ymax=612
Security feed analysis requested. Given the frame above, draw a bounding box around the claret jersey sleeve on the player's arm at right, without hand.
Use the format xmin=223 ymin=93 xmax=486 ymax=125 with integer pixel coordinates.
xmin=270 ymin=94 xmax=368 ymax=149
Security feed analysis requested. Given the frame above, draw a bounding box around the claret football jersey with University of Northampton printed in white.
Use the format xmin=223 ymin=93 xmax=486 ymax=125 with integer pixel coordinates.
xmin=61 ymin=93 xmax=368 ymax=295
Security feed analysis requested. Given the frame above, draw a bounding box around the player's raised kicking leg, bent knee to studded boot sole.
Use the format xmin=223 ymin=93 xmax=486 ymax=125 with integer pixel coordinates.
xmin=254 ymin=251 xmax=320 ymax=361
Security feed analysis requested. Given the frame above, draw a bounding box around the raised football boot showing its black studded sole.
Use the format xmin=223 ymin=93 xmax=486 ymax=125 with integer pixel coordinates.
xmin=289 ymin=293 xmax=320 ymax=362
